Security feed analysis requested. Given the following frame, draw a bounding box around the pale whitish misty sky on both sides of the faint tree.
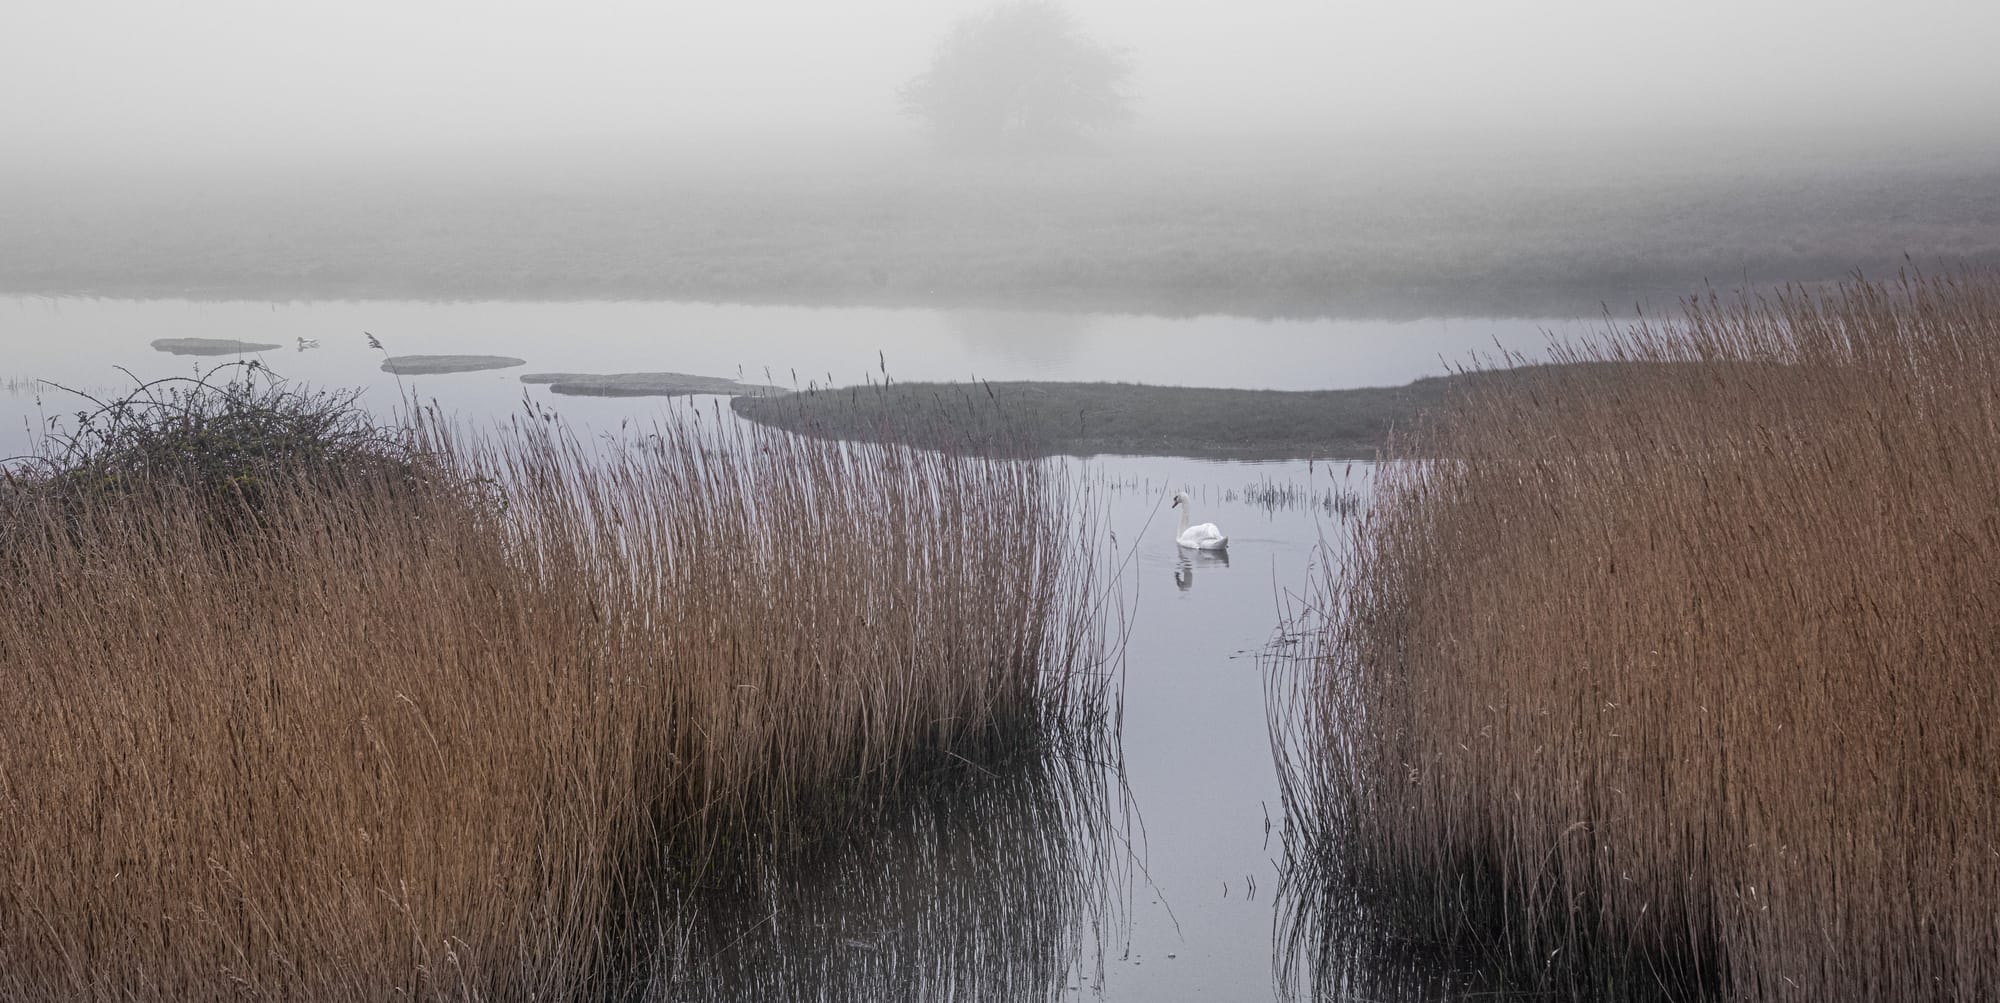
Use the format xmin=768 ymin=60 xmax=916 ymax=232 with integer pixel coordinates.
xmin=0 ymin=0 xmax=2000 ymax=164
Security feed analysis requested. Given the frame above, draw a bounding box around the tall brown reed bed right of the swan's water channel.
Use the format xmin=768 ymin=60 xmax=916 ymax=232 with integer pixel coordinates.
xmin=1272 ymin=274 xmax=2000 ymax=1001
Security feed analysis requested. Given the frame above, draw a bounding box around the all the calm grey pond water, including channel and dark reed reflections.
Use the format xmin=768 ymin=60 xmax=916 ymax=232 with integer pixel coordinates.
xmin=0 ymin=300 xmax=1576 ymax=1001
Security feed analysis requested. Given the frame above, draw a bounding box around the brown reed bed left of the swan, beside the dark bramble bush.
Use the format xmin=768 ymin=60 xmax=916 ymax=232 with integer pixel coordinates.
xmin=0 ymin=387 xmax=1108 ymax=1001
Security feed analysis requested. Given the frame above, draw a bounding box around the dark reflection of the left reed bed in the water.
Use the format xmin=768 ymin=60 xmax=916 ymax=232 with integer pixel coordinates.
xmin=660 ymin=749 xmax=1128 ymax=1003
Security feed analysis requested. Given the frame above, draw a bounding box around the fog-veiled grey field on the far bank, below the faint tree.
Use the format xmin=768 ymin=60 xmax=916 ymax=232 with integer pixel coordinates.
xmin=0 ymin=140 xmax=2000 ymax=315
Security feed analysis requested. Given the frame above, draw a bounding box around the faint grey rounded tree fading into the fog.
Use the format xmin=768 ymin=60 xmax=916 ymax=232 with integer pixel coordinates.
xmin=900 ymin=0 xmax=1132 ymax=152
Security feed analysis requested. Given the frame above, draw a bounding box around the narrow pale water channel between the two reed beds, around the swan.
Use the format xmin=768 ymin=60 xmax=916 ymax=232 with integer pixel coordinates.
xmin=1094 ymin=458 xmax=1366 ymax=1001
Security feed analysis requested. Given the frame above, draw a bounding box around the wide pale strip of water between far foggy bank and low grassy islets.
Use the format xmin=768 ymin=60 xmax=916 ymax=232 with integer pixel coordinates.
xmin=0 ymin=298 xmax=1574 ymax=456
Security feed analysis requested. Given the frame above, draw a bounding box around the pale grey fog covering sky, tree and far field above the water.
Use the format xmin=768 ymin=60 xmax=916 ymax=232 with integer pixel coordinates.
xmin=0 ymin=0 xmax=2000 ymax=318
